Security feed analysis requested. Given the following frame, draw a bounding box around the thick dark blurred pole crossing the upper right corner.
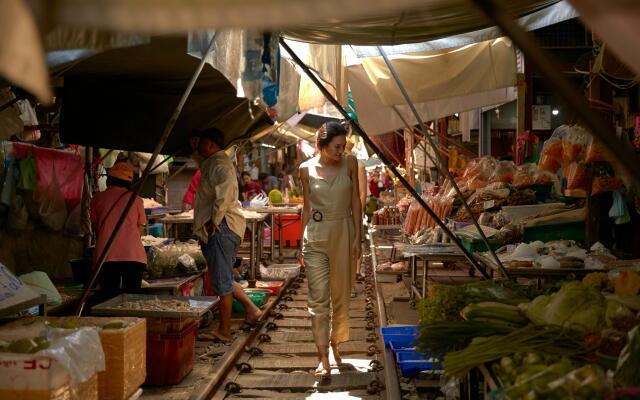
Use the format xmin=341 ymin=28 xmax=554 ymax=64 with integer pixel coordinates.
xmin=473 ymin=0 xmax=640 ymax=184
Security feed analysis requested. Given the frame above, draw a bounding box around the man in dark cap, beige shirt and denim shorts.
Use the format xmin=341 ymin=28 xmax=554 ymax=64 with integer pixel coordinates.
xmin=194 ymin=128 xmax=262 ymax=341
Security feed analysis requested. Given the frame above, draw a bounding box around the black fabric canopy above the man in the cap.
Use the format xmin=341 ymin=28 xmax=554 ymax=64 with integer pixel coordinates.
xmin=52 ymin=37 xmax=272 ymax=155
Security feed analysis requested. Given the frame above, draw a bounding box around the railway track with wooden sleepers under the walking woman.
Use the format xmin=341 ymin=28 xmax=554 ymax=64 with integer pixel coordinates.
xmin=207 ymin=239 xmax=397 ymax=400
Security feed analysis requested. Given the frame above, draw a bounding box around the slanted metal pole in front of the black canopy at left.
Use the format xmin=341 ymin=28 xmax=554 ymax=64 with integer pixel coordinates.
xmin=76 ymin=35 xmax=215 ymax=316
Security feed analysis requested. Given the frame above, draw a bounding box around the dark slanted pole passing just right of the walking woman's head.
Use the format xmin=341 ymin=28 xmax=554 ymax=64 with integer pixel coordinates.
xmin=280 ymin=37 xmax=491 ymax=279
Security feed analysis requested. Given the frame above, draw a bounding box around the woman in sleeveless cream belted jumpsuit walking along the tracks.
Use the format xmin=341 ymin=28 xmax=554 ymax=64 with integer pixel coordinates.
xmin=300 ymin=122 xmax=362 ymax=377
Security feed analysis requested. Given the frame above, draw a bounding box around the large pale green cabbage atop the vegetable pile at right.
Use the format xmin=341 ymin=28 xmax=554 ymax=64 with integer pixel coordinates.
xmin=520 ymin=281 xmax=607 ymax=332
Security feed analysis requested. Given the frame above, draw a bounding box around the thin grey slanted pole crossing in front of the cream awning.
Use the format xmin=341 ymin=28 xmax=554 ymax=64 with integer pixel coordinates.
xmin=377 ymin=46 xmax=509 ymax=279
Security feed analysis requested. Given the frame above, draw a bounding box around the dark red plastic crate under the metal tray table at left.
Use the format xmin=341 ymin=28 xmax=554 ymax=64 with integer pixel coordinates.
xmin=145 ymin=321 xmax=198 ymax=385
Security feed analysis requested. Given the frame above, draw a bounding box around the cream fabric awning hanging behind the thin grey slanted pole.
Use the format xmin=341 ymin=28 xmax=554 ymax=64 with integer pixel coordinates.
xmin=347 ymin=39 xmax=517 ymax=135
